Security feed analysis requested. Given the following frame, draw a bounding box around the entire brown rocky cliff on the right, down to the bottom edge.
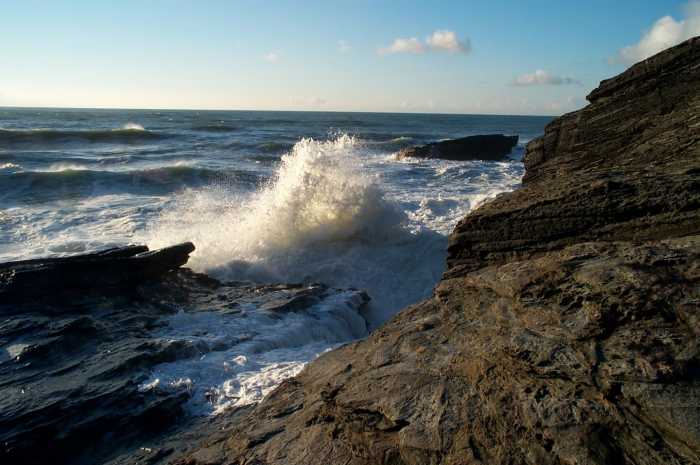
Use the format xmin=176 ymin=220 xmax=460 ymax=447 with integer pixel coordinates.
xmin=181 ymin=39 xmax=700 ymax=465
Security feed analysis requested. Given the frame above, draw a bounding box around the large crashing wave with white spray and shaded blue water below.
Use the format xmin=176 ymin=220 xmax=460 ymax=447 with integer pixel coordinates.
xmin=140 ymin=135 xmax=447 ymax=324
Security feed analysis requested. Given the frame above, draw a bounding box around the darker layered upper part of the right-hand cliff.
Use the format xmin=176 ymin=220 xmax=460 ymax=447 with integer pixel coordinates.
xmin=448 ymin=38 xmax=700 ymax=276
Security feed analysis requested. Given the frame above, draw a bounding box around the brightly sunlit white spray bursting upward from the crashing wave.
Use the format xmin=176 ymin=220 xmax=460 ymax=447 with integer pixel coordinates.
xmin=146 ymin=136 xmax=405 ymax=258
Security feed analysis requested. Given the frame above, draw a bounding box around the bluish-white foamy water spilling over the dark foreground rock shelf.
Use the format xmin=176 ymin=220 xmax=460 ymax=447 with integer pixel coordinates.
xmin=139 ymin=291 xmax=367 ymax=415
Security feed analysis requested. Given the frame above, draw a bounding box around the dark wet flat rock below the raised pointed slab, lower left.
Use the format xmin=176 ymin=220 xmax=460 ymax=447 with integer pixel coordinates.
xmin=0 ymin=266 xmax=369 ymax=465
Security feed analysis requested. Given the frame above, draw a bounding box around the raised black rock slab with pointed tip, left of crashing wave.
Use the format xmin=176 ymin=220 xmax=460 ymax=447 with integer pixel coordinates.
xmin=0 ymin=242 xmax=194 ymax=302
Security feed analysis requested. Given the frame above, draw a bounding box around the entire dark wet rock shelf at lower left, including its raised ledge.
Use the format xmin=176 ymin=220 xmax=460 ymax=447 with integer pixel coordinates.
xmin=0 ymin=264 xmax=369 ymax=465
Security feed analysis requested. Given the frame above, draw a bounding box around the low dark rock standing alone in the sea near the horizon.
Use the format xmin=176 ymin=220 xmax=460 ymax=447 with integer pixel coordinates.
xmin=397 ymin=134 xmax=518 ymax=161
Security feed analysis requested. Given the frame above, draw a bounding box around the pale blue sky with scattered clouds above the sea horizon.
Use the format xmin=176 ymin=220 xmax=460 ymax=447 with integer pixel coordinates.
xmin=0 ymin=0 xmax=700 ymax=115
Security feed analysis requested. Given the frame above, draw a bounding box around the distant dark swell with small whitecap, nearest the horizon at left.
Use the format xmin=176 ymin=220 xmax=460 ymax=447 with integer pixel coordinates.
xmin=0 ymin=123 xmax=168 ymax=144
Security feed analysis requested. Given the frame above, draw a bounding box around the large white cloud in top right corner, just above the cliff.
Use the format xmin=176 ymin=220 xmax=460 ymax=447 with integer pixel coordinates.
xmin=608 ymin=1 xmax=700 ymax=65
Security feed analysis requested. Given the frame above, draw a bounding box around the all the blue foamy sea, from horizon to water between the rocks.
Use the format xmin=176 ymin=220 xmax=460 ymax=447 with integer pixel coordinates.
xmin=0 ymin=109 xmax=551 ymax=414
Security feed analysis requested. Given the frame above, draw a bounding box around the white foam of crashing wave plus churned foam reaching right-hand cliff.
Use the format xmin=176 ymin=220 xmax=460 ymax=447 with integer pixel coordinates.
xmin=139 ymin=135 xmax=521 ymax=327
